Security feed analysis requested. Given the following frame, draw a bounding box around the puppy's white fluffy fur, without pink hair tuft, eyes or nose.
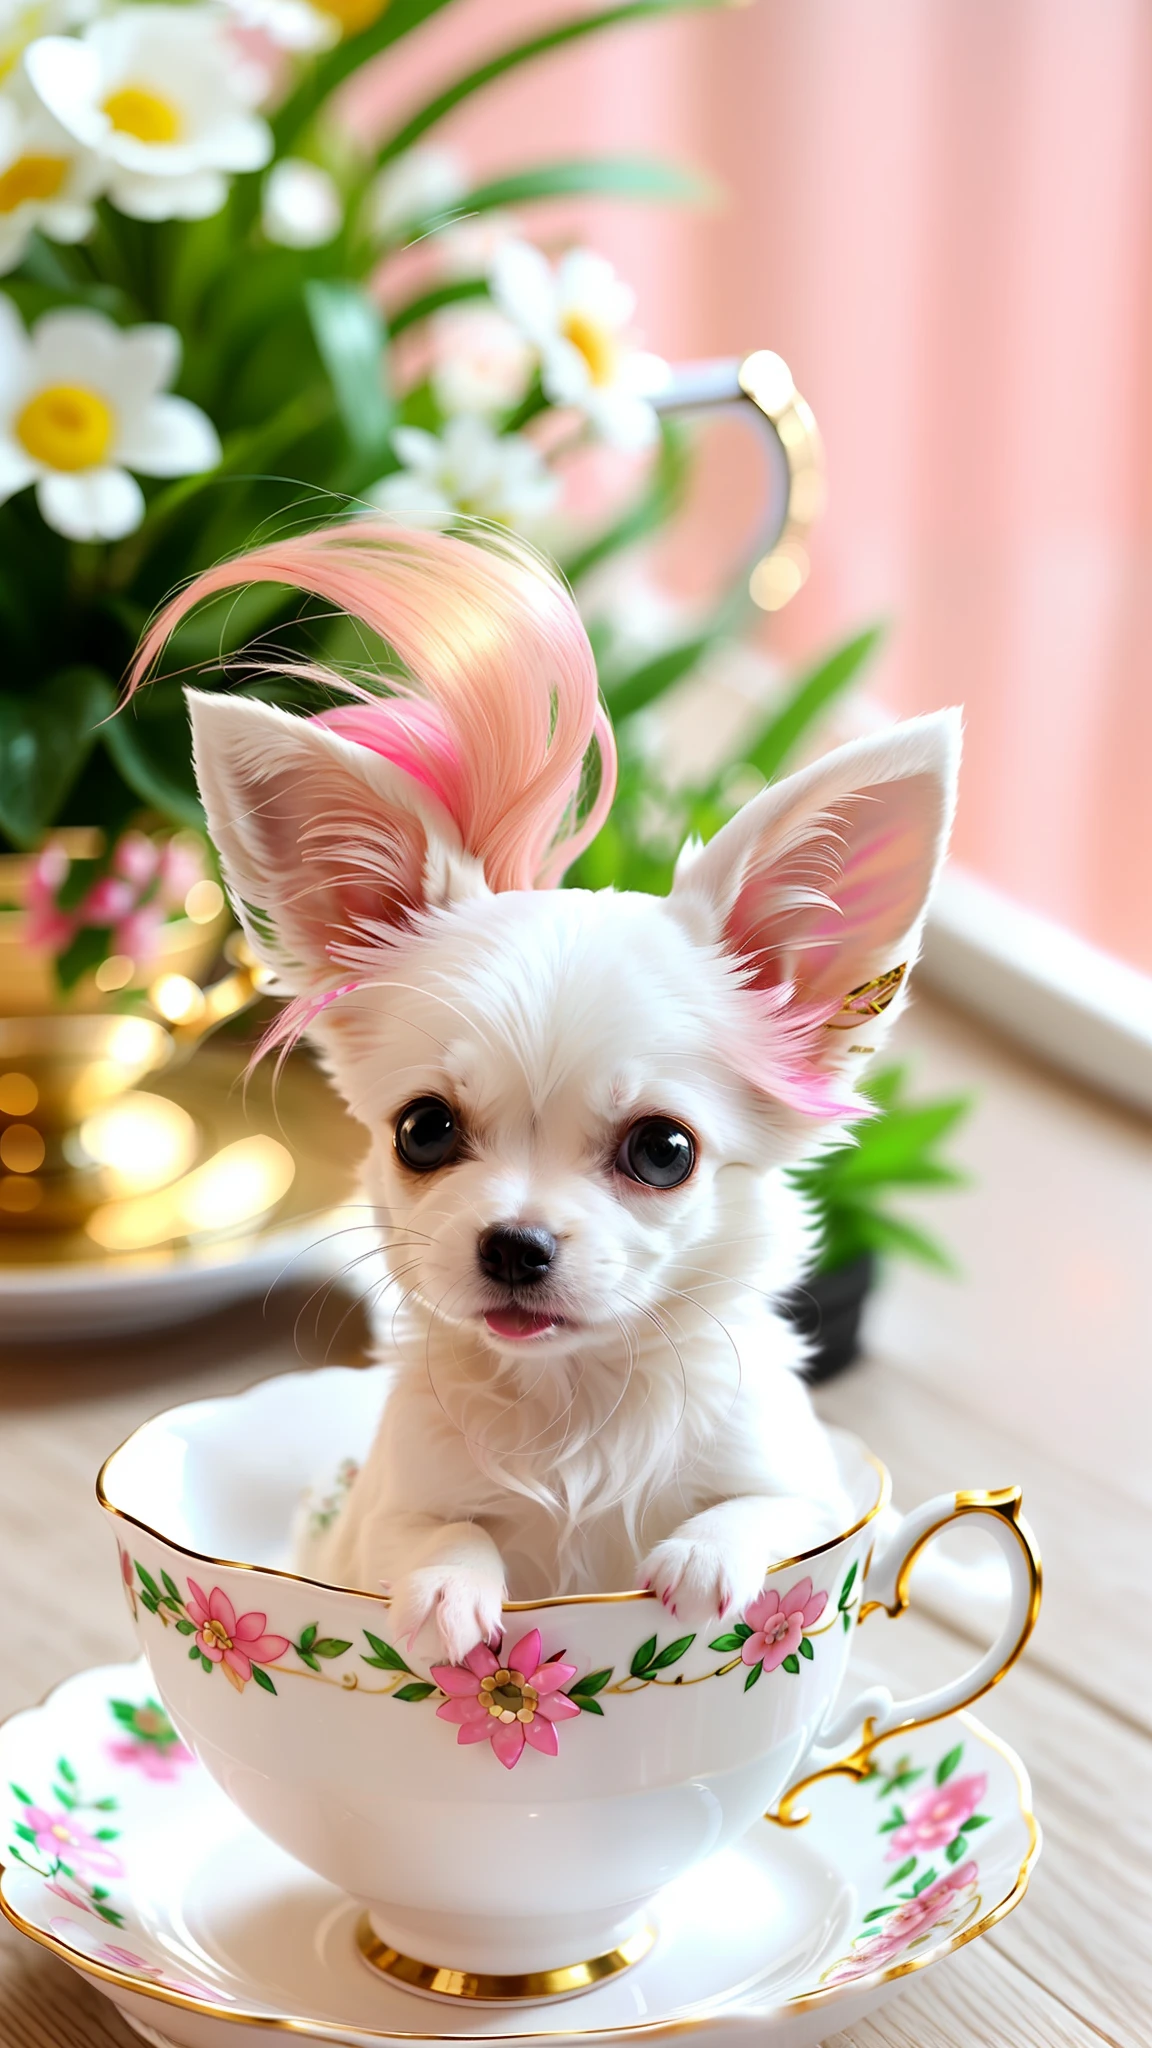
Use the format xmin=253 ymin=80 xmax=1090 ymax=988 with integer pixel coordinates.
xmin=191 ymin=696 xmax=959 ymax=1659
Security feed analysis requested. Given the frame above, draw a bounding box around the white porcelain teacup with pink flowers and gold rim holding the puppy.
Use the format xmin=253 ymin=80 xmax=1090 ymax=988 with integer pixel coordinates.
xmin=98 ymin=1368 xmax=1039 ymax=1999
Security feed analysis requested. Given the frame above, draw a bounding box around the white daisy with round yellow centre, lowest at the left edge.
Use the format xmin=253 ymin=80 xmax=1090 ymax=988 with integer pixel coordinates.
xmin=0 ymin=293 xmax=219 ymax=541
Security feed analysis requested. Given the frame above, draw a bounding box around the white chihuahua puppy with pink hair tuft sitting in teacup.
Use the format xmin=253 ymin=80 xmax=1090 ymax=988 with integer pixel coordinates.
xmin=139 ymin=526 xmax=959 ymax=1661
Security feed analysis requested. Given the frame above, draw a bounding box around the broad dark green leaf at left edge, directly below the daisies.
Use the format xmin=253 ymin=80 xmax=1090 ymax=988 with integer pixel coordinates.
xmin=0 ymin=668 xmax=117 ymax=848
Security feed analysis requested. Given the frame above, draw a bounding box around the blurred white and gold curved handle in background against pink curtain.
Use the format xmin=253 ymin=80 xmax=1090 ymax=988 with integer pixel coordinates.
xmin=652 ymin=348 xmax=826 ymax=612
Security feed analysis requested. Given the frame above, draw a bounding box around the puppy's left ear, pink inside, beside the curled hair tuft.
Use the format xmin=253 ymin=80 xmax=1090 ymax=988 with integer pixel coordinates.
xmin=187 ymin=690 xmax=471 ymax=995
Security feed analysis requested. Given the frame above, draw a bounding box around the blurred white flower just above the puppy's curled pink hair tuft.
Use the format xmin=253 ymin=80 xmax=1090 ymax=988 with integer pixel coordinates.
xmin=367 ymin=414 xmax=560 ymax=532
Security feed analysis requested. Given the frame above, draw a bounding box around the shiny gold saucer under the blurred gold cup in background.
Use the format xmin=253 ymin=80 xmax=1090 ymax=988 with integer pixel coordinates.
xmin=0 ymin=1044 xmax=365 ymax=1269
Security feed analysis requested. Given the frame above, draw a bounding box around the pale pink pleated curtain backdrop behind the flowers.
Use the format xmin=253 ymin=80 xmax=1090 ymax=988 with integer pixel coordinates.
xmin=354 ymin=0 xmax=1152 ymax=969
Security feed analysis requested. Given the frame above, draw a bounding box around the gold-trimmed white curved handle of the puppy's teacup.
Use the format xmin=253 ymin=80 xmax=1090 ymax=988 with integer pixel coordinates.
xmin=769 ymin=1487 xmax=1041 ymax=1827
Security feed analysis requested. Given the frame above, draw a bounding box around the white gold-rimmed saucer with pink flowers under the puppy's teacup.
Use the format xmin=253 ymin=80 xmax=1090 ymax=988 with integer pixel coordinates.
xmin=0 ymin=1663 xmax=1039 ymax=2048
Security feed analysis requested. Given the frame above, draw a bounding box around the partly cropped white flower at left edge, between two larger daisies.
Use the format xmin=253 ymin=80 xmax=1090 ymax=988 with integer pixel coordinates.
xmin=0 ymin=90 xmax=100 ymax=274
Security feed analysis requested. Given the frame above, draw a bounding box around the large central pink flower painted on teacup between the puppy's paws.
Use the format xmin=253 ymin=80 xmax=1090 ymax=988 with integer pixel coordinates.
xmin=433 ymin=1628 xmax=580 ymax=1772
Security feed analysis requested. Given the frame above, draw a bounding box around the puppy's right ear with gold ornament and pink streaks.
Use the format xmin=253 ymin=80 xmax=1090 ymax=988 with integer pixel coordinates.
xmin=670 ymin=711 xmax=959 ymax=1108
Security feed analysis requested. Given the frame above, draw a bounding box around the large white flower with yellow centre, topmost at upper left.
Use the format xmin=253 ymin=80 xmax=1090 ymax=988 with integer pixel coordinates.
xmin=25 ymin=6 xmax=273 ymax=221
